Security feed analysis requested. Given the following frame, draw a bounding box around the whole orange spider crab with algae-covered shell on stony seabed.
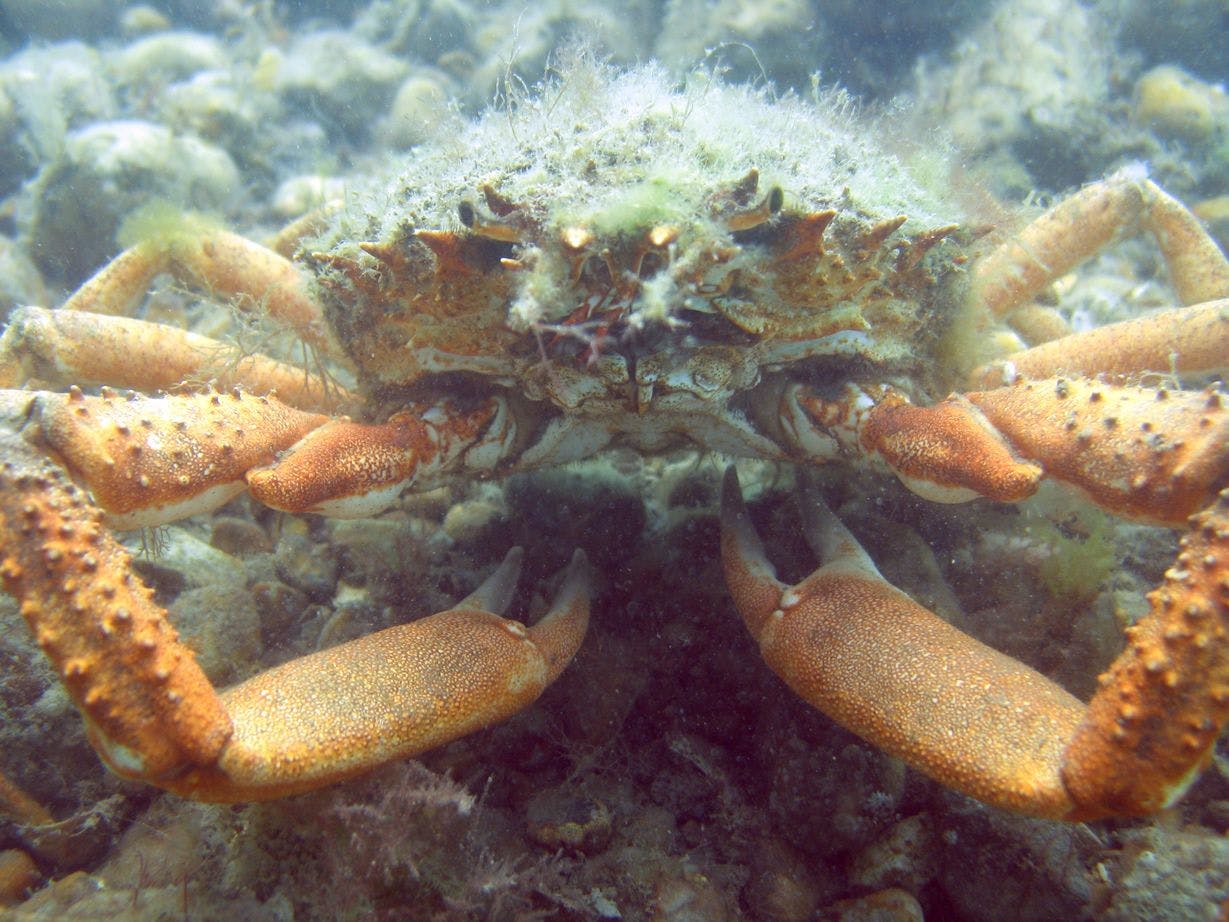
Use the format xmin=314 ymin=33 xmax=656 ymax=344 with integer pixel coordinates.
xmin=0 ymin=65 xmax=1229 ymax=820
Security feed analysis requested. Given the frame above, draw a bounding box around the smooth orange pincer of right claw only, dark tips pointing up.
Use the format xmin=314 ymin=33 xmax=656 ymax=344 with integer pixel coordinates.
xmin=721 ymin=468 xmax=1084 ymax=816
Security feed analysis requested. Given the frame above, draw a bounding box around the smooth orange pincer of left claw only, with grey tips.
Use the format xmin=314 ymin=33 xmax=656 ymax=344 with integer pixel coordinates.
xmin=158 ymin=547 xmax=589 ymax=803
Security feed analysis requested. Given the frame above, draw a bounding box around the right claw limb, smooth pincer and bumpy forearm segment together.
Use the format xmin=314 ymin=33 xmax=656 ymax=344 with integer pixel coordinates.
xmin=721 ymin=468 xmax=1229 ymax=820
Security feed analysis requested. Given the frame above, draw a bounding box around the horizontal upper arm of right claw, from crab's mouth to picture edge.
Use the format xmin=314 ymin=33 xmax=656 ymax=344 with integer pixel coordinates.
xmin=783 ymin=379 xmax=1229 ymax=526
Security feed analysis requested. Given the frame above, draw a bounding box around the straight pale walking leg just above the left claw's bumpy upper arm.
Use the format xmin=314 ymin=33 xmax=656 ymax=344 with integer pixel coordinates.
xmin=0 ymin=307 xmax=353 ymax=412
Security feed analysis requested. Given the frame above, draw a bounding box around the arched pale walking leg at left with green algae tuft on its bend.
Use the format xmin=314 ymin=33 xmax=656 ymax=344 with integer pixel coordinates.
xmin=61 ymin=230 xmax=345 ymax=359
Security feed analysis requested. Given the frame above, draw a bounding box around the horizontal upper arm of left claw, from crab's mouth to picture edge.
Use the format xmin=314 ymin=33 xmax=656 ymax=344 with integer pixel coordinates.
xmin=0 ymin=388 xmax=515 ymax=529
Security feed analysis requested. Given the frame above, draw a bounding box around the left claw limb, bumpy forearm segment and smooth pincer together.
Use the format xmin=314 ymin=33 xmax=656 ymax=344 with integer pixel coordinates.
xmin=0 ymin=403 xmax=589 ymax=802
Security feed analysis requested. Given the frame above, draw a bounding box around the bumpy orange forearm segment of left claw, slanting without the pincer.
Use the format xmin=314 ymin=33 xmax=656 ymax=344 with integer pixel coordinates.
xmin=0 ymin=433 xmax=231 ymax=779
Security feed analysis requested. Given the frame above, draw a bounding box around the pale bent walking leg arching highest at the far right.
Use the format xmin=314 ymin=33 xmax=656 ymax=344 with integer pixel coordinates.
xmin=972 ymin=170 xmax=1229 ymax=316
